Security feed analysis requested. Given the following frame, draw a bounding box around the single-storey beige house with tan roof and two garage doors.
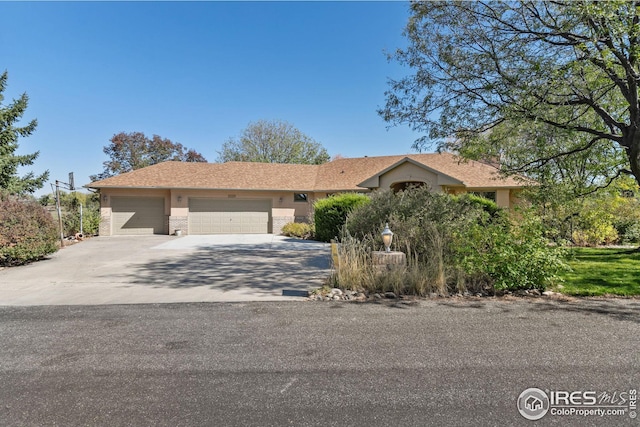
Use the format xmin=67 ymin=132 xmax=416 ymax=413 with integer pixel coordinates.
xmin=87 ymin=153 xmax=524 ymax=236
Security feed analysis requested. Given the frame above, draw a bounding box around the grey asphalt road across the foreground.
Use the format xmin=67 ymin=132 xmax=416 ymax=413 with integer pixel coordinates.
xmin=0 ymin=299 xmax=640 ymax=426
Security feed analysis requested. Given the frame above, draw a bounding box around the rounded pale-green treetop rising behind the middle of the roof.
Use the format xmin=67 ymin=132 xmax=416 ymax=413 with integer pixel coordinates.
xmin=218 ymin=120 xmax=329 ymax=165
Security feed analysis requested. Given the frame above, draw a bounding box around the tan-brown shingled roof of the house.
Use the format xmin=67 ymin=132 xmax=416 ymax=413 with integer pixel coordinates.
xmin=87 ymin=153 xmax=522 ymax=192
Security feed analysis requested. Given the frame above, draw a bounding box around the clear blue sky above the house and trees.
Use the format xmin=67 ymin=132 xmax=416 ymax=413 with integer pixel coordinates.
xmin=5 ymin=2 xmax=419 ymax=194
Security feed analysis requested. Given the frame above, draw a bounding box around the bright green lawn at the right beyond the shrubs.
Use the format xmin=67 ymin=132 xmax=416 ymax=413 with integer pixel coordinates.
xmin=552 ymin=248 xmax=640 ymax=296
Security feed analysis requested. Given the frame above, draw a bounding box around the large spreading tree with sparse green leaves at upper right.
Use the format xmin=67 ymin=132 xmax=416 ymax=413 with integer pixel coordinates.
xmin=379 ymin=1 xmax=640 ymax=187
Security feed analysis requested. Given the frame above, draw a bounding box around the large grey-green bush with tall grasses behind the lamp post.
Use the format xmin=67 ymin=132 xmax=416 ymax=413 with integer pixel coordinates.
xmin=341 ymin=187 xmax=484 ymax=295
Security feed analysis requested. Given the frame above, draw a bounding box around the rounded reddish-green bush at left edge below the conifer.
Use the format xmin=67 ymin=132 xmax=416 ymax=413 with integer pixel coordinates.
xmin=0 ymin=195 xmax=58 ymax=266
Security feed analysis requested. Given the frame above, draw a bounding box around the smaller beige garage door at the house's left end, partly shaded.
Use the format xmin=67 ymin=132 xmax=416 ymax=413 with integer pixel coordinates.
xmin=111 ymin=197 xmax=167 ymax=235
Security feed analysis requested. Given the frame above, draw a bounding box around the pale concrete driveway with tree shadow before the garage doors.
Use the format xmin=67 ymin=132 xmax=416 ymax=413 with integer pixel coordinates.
xmin=0 ymin=234 xmax=330 ymax=305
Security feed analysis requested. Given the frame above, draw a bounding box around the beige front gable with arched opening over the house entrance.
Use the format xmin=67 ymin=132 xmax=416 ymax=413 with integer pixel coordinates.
xmin=358 ymin=157 xmax=464 ymax=190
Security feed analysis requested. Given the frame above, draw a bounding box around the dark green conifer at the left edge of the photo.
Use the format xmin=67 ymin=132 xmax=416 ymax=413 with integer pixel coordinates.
xmin=0 ymin=71 xmax=49 ymax=194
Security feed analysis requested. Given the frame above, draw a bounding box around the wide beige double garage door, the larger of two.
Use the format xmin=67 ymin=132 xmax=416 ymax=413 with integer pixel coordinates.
xmin=189 ymin=198 xmax=271 ymax=234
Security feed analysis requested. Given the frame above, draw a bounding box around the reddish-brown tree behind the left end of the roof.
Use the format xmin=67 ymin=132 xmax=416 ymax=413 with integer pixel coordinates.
xmin=90 ymin=132 xmax=206 ymax=181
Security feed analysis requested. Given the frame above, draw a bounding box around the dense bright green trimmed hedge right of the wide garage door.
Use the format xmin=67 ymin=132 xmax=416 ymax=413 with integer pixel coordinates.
xmin=314 ymin=193 xmax=370 ymax=242
